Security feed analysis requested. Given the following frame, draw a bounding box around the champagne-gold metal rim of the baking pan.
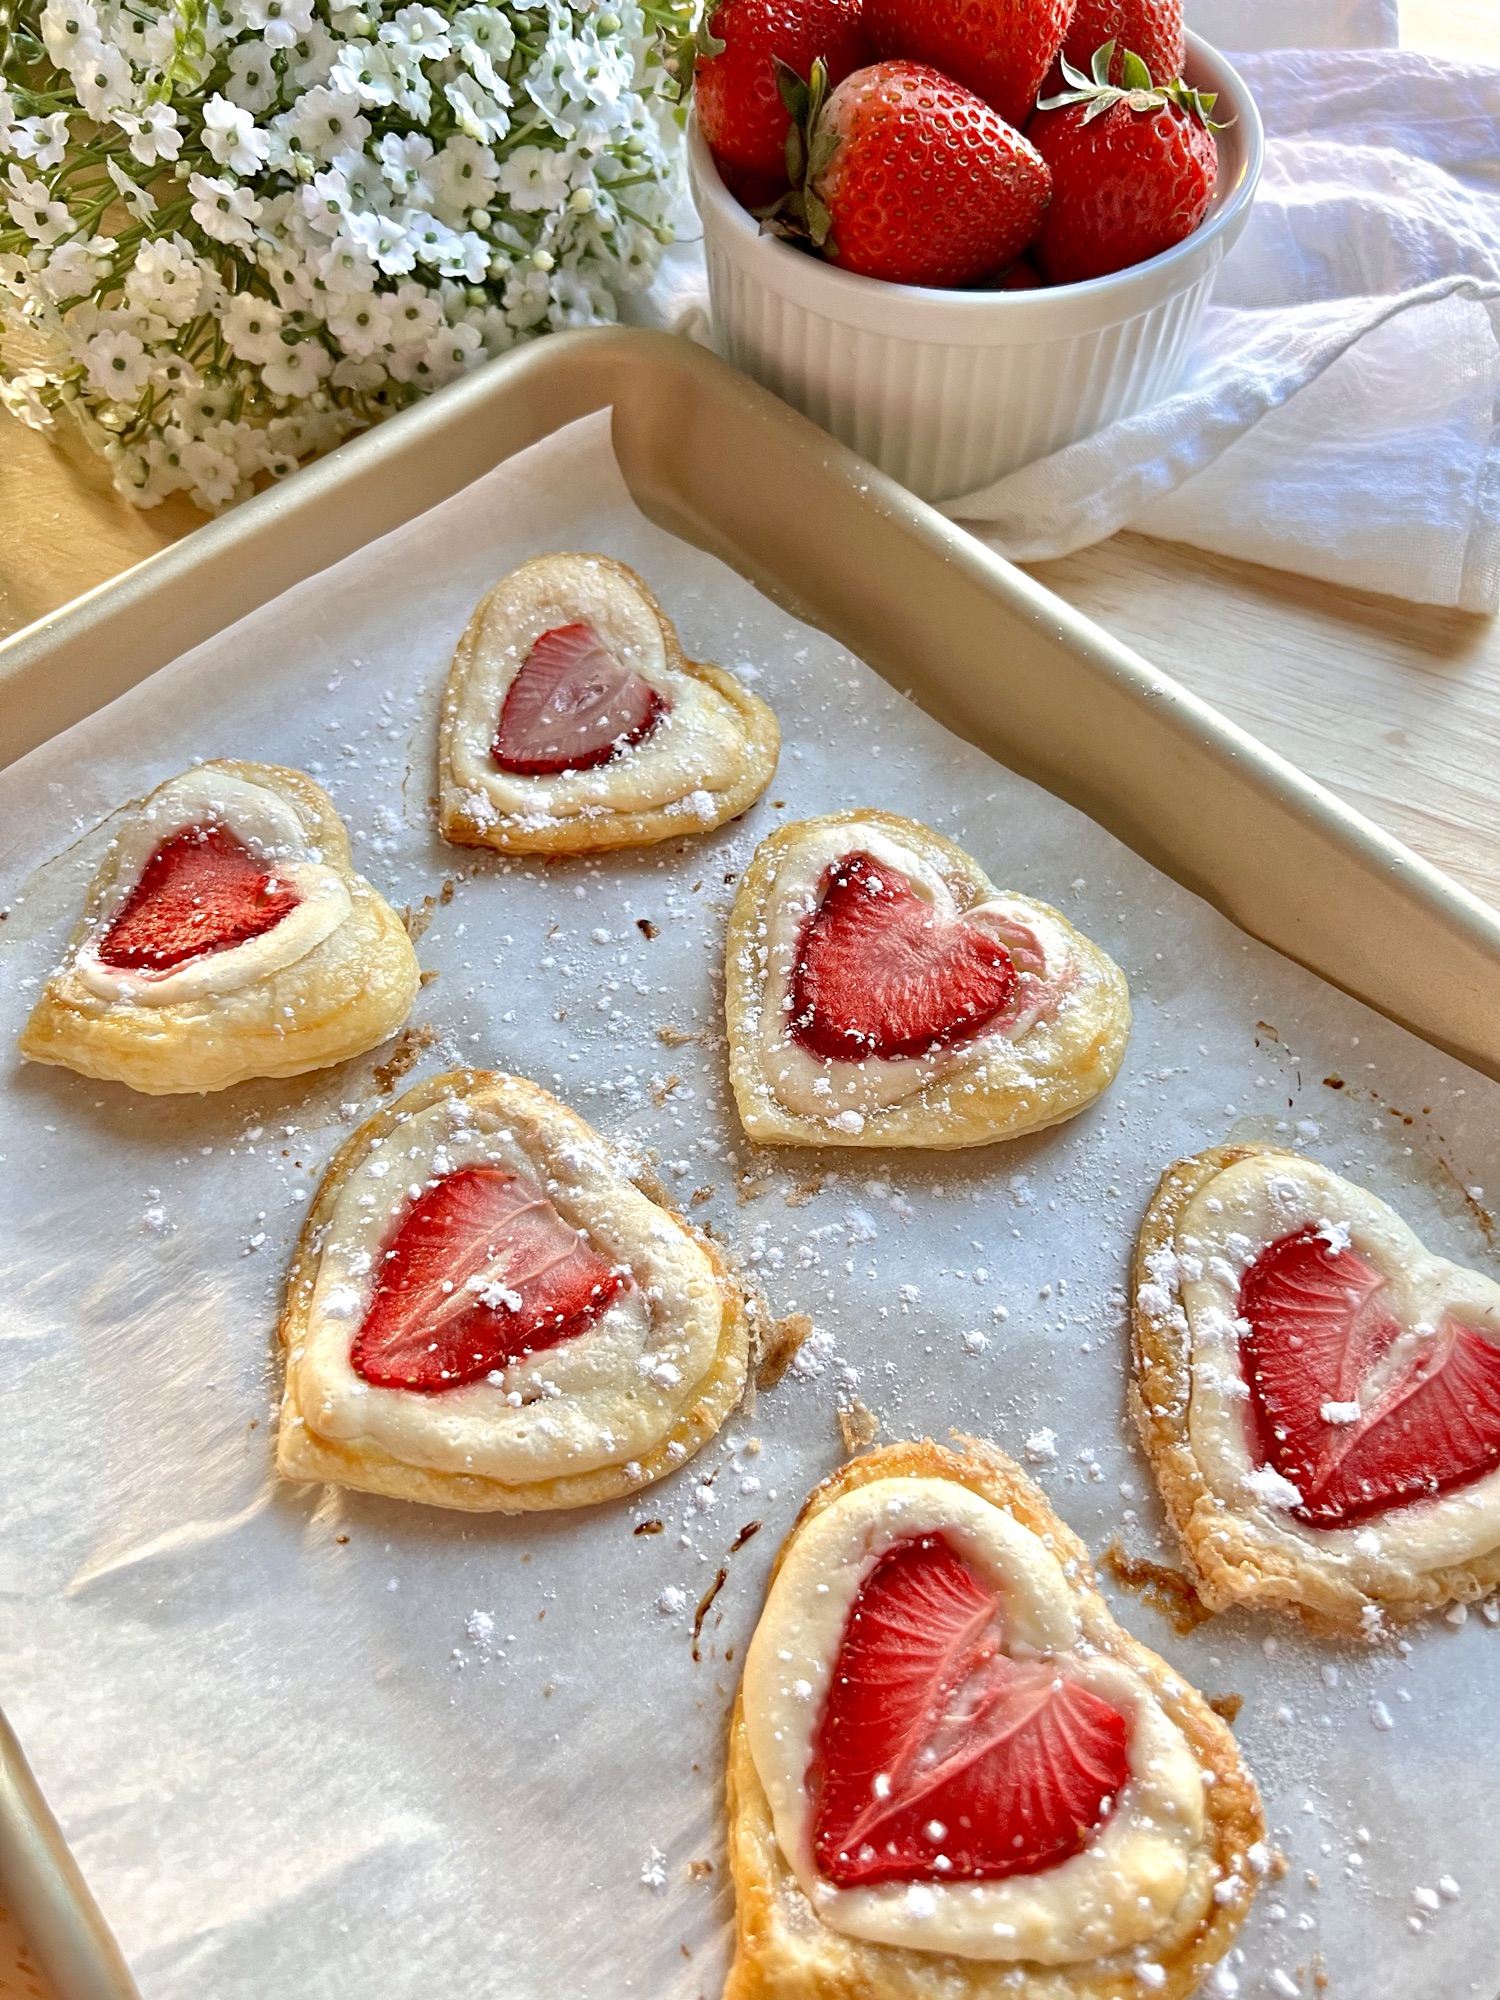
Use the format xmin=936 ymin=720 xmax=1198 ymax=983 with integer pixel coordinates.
xmin=0 ymin=332 xmax=1500 ymax=2000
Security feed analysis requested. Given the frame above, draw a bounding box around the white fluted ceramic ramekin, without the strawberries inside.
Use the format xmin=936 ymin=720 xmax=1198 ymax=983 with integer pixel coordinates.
xmin=688 ymin=34 xmax=1262 ymax=500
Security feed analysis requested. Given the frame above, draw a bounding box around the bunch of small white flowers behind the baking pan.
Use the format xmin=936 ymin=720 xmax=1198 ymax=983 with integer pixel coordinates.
xmin=0 ymin=0 xmax=690 ymax=510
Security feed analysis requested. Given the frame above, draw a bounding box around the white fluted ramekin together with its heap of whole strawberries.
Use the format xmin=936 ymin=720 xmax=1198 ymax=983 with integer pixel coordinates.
xmin=678 ymin=0 xmax=1262 ymax=500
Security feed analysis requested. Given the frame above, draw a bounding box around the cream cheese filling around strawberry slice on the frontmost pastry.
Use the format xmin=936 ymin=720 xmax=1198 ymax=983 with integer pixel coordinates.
xmin=744 ymin=1478 xmax=1204 ymax=1964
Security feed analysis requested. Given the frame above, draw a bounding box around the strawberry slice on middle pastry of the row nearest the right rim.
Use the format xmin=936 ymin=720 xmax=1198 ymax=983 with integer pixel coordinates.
xmin=790 ymin=854 xmax=1016 ymax=1062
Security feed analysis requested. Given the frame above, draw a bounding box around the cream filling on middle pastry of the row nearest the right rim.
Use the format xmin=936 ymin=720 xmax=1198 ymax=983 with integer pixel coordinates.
xmin=740 ymin=820 xmax=1074 ymax=1132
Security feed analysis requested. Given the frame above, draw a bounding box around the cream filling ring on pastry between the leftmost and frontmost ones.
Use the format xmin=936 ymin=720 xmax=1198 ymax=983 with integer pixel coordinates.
xmin=288 ymin=1096 xmax=722 ymax=1486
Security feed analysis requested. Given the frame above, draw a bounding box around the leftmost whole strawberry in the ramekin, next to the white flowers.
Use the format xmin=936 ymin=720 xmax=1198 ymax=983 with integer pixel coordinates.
xmin=694 ymin=0 xmax=870 ymax=185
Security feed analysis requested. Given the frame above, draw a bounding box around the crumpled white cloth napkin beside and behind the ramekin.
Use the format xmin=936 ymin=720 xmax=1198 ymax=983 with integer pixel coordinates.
xmin=632 ymin=0 xmax=1500 ymax=612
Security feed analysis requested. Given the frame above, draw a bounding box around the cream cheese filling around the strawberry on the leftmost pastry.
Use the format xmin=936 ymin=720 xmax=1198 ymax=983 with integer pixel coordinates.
xmin=72 ymin=766 xmax=352 ymax=1006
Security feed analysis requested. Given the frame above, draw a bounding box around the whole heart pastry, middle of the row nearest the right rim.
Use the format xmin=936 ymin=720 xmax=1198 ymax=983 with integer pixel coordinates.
xmin=726 ymin=810 xmax=1130 ymax=1148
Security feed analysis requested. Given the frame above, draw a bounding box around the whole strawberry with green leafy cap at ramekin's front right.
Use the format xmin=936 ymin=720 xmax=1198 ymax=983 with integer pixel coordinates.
xmin=1026 ymin=42 xmax=1218 ymax=284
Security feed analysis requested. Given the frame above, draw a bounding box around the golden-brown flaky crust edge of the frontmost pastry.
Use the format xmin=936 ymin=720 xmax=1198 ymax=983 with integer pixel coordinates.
xmin=724 ymin=1438 xmax=1264 ymax=2000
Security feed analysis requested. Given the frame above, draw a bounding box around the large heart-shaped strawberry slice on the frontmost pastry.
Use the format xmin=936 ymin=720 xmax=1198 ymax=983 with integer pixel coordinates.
xmin=808 ymin=1534 xmax=1130 ymax=1888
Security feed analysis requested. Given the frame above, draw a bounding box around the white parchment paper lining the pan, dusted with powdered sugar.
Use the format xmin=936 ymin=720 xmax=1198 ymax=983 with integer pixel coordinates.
xmin=0 ymin=416 xmax=1500 ymax=2000
